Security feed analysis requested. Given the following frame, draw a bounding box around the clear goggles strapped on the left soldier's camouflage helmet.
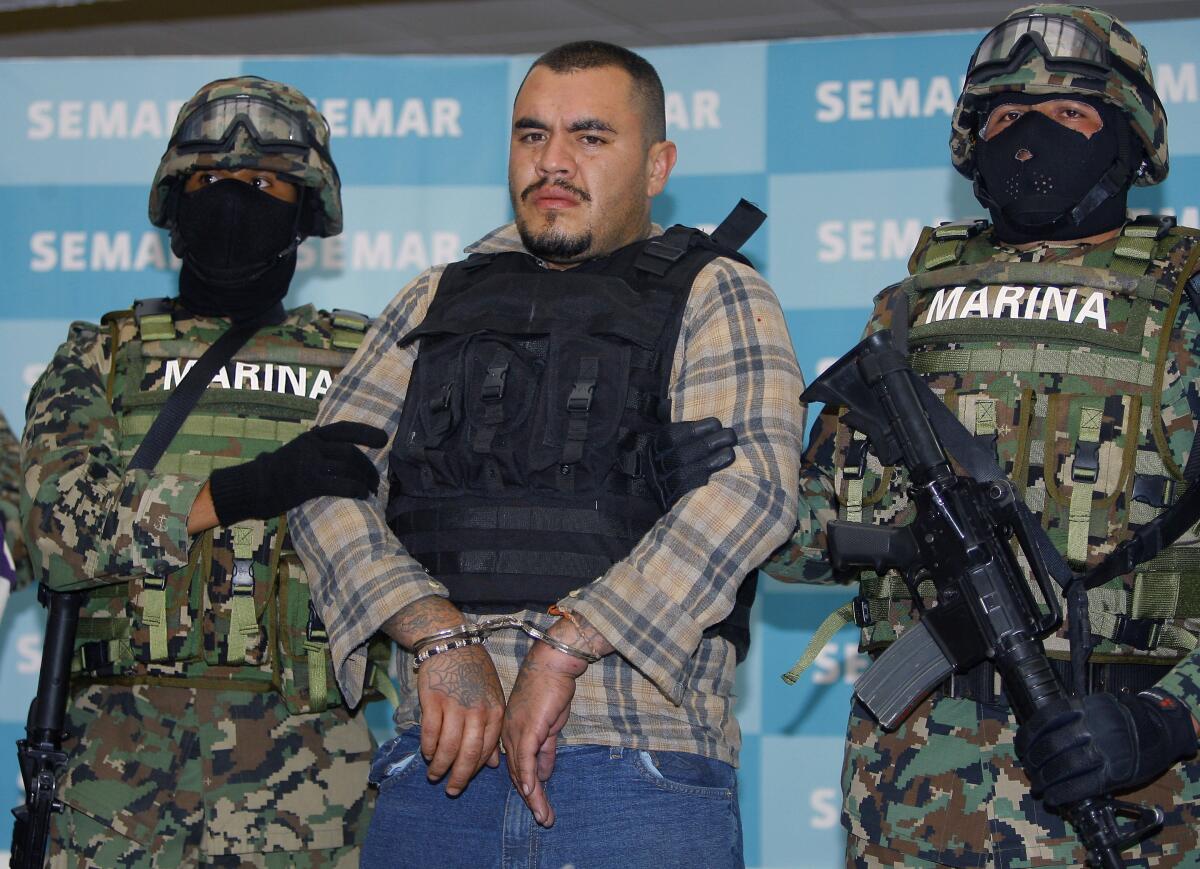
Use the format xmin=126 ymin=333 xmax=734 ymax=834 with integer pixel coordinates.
xmin=170 ymin=95 xmax=325 ymax=152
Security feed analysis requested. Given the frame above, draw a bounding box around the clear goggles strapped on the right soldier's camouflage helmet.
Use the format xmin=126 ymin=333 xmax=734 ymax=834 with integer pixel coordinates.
xmin=967 ymin=13 xmax=1162 ymax=108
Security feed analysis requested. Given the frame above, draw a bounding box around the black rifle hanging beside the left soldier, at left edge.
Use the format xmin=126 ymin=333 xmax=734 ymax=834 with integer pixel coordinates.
xmin=8 ymin=586 xmax=86 ymax=869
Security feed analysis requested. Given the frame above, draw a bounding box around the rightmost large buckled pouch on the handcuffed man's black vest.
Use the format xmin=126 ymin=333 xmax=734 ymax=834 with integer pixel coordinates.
xmin=529 ymin=332 xmax=646 ymax=492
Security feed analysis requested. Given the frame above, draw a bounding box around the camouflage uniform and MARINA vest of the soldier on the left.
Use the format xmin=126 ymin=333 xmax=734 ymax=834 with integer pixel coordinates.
xmin=23 ymin=79 xmax=374 ymax=869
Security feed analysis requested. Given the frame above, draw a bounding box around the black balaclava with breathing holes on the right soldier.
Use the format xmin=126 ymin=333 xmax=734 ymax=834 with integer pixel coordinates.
xmin=976 ymin=94 xmax=1141 ymax=244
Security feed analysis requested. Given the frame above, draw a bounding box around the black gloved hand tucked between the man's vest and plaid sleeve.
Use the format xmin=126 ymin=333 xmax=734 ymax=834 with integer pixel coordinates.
xmin=646 ymin=416 xmax=738 ymax=510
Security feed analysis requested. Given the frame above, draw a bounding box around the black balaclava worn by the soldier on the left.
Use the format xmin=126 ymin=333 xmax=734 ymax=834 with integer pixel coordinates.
xmin=172 ymin=178 xmax=304 ymax=320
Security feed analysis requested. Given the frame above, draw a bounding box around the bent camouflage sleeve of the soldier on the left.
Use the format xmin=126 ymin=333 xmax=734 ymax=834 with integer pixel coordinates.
xmin=20 ymin=323 xmax=204 ymax=591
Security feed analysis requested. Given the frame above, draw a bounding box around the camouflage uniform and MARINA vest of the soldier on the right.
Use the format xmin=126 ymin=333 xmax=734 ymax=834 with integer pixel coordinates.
xmin=766 ymin=6 xmax=1200 ymax=869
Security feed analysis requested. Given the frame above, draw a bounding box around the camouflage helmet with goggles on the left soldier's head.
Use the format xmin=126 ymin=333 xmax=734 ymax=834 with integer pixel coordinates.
xmin=150 ymin=76 xmax=342 ymax=236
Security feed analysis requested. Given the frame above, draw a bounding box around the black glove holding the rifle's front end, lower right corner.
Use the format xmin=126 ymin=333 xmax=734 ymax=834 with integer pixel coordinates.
xmin=1016 ymin=688 xmax=1196 ymax=808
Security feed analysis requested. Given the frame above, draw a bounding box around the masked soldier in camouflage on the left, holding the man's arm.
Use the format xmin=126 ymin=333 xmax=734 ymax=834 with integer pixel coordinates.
xmin=22 ymin=77 xmax=382 ymax=869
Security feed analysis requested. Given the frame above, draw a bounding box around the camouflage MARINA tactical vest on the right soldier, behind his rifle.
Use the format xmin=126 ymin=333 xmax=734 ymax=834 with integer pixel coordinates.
xmin=835 ymin=216 xmax=1200 ymax=664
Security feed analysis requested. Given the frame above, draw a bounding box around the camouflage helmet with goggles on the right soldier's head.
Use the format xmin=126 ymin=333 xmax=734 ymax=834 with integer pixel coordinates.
xmin=950 ymin=4 xmax=1169 ymax=186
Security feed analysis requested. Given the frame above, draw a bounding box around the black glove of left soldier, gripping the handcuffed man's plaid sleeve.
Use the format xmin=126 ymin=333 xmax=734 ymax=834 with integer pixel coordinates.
xmin=209 ymin=421 xmax=388 ymax=526
